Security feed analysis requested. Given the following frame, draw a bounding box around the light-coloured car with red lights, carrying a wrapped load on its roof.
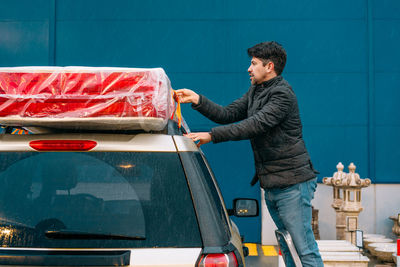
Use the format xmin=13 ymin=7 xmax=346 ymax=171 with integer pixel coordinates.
xmin=0 ymin=120 xmax=259 ymax=267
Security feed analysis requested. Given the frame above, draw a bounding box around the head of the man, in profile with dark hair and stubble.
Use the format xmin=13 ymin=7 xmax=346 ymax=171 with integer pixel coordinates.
xmin=247 ymin=41 xmax=286 ymax=84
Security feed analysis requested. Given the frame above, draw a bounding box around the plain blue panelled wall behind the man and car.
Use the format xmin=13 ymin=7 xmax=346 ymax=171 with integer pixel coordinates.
xmin=0 ymin=0 xmax=400 ymax=241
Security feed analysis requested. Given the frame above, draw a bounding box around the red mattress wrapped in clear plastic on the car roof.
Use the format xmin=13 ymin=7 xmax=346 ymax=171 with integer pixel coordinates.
xmin=0 ymin=67 xmax=174 ymax=131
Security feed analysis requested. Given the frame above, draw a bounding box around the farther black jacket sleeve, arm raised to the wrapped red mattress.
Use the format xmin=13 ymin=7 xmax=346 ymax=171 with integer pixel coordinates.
xmin=192 ymin=92 xmax=248 ymax=124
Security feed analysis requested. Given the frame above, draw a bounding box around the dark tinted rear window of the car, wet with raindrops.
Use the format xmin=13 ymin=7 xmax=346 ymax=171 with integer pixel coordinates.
xmin=0 ymin=152 xmax=202 ymax=248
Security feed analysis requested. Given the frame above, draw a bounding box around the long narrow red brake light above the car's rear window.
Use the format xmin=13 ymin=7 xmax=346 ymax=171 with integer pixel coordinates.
xmin=29 ymin=140 xmax=97 ymax=151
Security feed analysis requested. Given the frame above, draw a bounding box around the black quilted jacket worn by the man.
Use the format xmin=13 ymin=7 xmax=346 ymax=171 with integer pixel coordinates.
xmin=192 ymin=76 xmax=317 ymax=188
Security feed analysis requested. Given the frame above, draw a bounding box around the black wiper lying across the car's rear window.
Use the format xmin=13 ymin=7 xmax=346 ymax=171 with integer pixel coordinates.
xmin=44 ymin=230 xmax=146 ymax=240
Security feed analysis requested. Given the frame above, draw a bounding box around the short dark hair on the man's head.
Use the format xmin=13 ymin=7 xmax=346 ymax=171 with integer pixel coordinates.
xmin=247 ymin=41 xmax=286 ymax=75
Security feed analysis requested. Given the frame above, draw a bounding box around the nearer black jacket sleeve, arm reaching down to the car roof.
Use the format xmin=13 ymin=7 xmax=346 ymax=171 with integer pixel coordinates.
xmin=211 ymin=88 xmax=295 ymax=143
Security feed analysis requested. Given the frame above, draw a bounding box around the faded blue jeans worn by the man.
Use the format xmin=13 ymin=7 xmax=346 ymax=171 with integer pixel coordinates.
xmin=265 ymin=178 xmax=324 ymax=267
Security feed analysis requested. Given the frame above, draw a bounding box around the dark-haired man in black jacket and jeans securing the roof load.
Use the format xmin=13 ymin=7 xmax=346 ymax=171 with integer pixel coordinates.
xmin=177 ymin=41 xmax=323 ymax=267
